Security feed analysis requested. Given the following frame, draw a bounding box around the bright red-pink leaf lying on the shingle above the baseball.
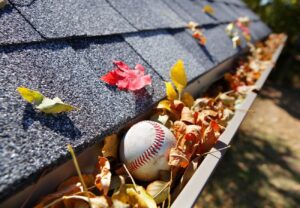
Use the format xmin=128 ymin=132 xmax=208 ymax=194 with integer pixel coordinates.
xmin=100 ymin=61 xmax=152 ymax=91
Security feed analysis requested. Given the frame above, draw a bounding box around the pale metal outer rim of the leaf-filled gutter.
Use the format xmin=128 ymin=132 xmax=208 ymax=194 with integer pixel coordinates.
xmin=172 ymin=36 xmax=285 ymax=208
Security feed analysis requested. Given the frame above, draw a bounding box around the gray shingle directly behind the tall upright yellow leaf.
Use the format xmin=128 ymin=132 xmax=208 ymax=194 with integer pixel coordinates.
xmin=125 ymin=30 xmax=205 ymax=80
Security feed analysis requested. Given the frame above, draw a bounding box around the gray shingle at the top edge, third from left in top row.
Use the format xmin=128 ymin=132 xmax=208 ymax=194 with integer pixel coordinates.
xmin=109 ymin=0 xmax=186 ymax=30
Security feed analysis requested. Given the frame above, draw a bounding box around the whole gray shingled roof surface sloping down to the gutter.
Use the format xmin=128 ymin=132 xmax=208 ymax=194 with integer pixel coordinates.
xmin=0 ymin=0 xmax=270 ymax=200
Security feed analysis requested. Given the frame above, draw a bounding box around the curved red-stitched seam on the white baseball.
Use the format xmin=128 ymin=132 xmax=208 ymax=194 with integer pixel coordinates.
xmin=128 ymin=121 xmax=165 ymax=171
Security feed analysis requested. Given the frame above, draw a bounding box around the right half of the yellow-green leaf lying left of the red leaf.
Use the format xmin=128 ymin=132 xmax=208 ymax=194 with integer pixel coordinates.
xmin=36 ymin=97 xmax=77 ymax=114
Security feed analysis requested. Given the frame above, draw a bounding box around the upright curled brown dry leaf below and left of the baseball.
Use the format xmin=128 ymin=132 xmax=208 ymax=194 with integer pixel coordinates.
xmin=95 ymin=157 xmax=111 ymax=195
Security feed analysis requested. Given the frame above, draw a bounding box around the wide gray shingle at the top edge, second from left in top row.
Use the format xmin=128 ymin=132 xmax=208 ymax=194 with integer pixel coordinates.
xmin=12 ymin=0 xmax=135 ymax=38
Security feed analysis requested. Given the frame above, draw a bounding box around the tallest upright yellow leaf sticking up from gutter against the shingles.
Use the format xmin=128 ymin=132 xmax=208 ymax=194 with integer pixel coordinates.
xmin=170 ymin=59 xmax=187 ymax=95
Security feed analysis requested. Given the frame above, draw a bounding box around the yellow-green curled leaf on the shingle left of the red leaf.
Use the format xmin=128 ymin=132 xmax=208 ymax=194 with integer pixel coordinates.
xmin=17 ymin=87 xmax=77 ymax=114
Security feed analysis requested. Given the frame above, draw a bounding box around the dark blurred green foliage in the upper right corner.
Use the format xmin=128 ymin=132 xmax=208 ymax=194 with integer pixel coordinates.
xmin=244 ymin=0 xmax=300 ymax=87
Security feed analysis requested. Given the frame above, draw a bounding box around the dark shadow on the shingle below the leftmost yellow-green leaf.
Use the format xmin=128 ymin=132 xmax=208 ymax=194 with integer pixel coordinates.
xmin=22 ymin=103 xmax=81 ymax=139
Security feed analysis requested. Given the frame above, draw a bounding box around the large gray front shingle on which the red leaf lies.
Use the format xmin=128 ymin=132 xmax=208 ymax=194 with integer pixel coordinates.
xmin=0 ymin=38 xmax=164 ymax=198
